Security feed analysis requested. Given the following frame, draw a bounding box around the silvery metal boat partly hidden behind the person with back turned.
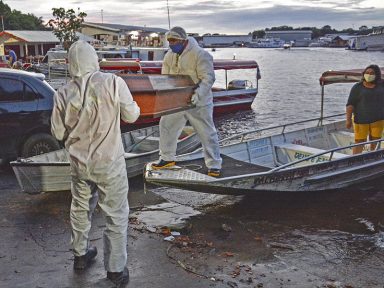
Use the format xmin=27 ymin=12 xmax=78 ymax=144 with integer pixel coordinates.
xmin=10 ymin=126 xmax=200 ymax=194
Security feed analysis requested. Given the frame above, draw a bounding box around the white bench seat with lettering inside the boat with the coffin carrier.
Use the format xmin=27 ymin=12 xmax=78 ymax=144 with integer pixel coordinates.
xmin=275 ymin=143 xmax=347 ymax=166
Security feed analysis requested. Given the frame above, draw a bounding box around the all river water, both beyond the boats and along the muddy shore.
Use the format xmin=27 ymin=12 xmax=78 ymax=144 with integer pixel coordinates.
xmin=138 ymin=48 xmax=384 ymax=288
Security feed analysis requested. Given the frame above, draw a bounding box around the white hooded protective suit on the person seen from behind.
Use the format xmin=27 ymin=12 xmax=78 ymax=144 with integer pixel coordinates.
xmin=51 ymin=41 xmax=140 ymax=272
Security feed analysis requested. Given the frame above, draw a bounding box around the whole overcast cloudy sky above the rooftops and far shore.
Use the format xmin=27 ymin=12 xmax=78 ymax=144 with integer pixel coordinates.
xmin=3 ymin=0 xmax=384 ymax=34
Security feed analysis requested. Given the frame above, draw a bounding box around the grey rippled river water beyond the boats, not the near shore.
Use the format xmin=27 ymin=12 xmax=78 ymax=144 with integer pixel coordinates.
xmin=210 ymin=48 xmax=384 ymax=134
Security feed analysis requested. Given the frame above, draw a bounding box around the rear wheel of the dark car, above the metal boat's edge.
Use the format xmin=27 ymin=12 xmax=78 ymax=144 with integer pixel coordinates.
xmin=21 ymin=133 xmax=60 ymax=158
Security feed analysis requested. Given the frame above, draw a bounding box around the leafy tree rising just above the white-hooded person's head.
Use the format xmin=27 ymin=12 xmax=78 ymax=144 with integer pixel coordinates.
xmin=48 ymin=8 xmax=87 ymax=49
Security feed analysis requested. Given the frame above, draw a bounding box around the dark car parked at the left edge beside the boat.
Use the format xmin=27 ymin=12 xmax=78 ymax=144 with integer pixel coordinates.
xmin=0 ymin=68 xmax=60 ymax=162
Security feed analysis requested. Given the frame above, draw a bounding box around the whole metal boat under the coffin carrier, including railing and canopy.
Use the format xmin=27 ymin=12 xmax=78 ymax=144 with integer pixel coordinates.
xmin=144 ymin=67 xmax=384 ymax=194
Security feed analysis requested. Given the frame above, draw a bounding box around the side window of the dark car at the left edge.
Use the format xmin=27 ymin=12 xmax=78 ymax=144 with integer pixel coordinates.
xmin=0 ymin=78 xmax=37 ymax=102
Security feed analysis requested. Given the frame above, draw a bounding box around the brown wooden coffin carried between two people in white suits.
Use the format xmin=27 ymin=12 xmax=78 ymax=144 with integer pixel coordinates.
xmin=118 ymin=74 xmax=196 ymax=118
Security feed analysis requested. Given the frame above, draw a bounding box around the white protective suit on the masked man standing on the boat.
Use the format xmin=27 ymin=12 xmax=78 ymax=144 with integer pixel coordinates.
xmin=160 ymin=37 xmax=222 ymax=169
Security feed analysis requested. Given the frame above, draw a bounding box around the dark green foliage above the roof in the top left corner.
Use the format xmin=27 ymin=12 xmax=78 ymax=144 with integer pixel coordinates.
xmin=0 ymin=1 xmax=45 ymax=30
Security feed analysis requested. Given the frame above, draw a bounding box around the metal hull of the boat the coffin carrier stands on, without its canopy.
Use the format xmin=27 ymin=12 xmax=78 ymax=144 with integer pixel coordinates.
xmin=145 ymin=121 xmax=384 ymax=194
